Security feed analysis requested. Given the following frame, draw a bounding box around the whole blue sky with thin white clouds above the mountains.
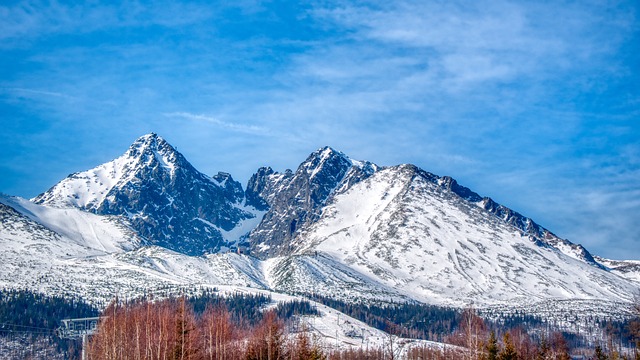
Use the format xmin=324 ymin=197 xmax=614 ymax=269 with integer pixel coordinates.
xmin=0 ymin=0 xmax=640 ymax=259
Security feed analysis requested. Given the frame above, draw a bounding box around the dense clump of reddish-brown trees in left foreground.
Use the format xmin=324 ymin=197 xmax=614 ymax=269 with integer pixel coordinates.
xmin=88 ymin=296 xmax=325 ymax=360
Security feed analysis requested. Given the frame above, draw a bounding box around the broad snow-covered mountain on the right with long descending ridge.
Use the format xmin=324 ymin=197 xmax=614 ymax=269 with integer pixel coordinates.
xmin=283 ymin=165 xmax=637 ymax=306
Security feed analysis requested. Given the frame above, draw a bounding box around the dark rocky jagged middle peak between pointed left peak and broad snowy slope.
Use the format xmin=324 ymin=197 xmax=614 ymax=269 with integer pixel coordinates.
xmin=246 ymin=147 xmax=378 ymax=258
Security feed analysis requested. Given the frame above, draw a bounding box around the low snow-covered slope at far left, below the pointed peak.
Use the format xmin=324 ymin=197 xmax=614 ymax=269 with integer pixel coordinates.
xmin=0 ymin=196 xmax=267 ymax=303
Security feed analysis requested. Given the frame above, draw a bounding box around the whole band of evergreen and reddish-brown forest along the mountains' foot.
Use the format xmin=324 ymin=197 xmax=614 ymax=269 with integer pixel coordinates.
xmin=0 ymin=289 xmax=640 ymax=360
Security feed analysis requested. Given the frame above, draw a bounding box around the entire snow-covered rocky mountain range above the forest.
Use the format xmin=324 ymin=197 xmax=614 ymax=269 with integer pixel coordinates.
xmin=0 ymin=134 xmax=640 ymax=322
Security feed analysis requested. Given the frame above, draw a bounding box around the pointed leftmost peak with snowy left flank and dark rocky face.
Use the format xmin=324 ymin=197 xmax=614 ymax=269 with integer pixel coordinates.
xmin=33 ymin=134 xmax=260 ymax=255
